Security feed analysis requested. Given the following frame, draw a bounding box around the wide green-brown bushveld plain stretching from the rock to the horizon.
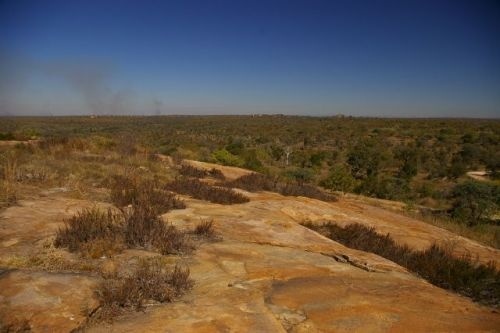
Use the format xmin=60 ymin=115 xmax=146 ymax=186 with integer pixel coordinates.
xmin=0 ymin=115 xmax=500 ymax=247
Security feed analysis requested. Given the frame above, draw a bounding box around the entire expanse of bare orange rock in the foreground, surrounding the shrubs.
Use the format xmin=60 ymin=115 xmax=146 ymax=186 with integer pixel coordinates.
xmin=0 ymin=165 xmax=500 ymax=332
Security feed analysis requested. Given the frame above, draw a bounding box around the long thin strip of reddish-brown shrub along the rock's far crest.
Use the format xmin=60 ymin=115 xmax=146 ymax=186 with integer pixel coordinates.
xmin=220 ymin=173 xmax=337 ymax=202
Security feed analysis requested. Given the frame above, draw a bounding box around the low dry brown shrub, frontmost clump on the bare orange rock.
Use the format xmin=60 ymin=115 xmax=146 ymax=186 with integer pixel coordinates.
xmin=96 ymin=258 xmax=193 ymax=319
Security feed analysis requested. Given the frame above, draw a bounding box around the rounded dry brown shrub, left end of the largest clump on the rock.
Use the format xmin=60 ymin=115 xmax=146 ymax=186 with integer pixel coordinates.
xmin=54 ymin=208 xmax=123 ymax=257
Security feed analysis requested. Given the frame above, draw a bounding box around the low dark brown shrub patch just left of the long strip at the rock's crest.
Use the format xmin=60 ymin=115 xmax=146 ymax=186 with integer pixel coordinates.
xmin=166 ymin=178 xmax=250 ymax=205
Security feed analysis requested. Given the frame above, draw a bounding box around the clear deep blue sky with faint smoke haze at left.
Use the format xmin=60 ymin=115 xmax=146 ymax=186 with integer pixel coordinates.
xmin=0 ymin=0 xmax=500 ymax=118
